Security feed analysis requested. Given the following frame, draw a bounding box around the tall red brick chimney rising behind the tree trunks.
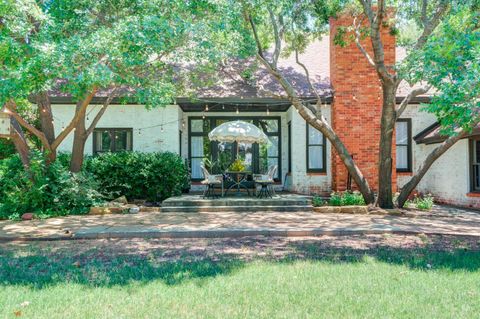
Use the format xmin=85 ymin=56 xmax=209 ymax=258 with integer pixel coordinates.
xmin=330 ymin=15 xmax=397 ymax=191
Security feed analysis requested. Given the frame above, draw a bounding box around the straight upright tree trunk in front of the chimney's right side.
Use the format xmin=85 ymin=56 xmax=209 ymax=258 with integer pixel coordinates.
xmin=377 ymin=83 xmax=396 ymax=208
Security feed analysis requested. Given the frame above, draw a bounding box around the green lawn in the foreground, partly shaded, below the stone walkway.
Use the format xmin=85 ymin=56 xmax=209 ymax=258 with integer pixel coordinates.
xmin=0 ymin=236 xmax=480 ymax=318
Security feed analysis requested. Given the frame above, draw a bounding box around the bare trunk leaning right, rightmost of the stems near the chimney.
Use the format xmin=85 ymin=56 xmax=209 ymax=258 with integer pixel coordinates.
xmin=398 ymin=132 xmax=466 ymax=207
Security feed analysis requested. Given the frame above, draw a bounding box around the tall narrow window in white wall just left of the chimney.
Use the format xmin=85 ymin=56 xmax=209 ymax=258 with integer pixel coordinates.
xmin=307 ymin=124 xmax=327 ymax=172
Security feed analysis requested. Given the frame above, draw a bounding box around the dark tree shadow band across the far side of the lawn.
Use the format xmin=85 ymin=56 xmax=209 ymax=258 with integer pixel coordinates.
xmin=0 ymin=238 xmax=480 ymax=289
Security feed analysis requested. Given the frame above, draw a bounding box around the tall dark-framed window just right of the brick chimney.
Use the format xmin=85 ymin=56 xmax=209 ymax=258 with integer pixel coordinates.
xmin=395 ymin=119 xmax=412 ymax=172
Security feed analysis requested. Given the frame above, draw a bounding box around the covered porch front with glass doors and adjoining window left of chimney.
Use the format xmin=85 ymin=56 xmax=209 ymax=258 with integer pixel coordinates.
xmin=178 ymin=99 xmax=331 ymax=194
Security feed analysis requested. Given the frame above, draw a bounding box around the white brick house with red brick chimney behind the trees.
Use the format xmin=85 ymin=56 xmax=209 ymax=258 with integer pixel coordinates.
xmin=51 ymin=13 xmax=480 ymax=207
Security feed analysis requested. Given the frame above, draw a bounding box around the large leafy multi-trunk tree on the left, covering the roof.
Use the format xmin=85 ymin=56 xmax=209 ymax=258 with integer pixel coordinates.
xmin=2 ymin=0 xmax=251 ymax=172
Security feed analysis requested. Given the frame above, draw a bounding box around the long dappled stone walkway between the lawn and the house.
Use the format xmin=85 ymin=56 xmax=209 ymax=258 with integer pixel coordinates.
xmin=0 ymin=206 xmax=480 ymax=241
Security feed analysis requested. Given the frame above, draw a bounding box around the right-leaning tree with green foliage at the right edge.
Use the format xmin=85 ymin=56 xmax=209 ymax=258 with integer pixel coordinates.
xmin=398 ymin=6 xmax=480 ymax=207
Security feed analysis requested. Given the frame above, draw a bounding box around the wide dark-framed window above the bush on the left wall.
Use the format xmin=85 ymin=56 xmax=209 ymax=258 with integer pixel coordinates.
xmin=93 ymin=128 xmax=132 ymax=154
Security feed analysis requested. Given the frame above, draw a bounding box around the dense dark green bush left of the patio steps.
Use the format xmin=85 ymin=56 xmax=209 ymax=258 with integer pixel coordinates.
xmin=85 ymin=152 xmax=189 ymax=201
